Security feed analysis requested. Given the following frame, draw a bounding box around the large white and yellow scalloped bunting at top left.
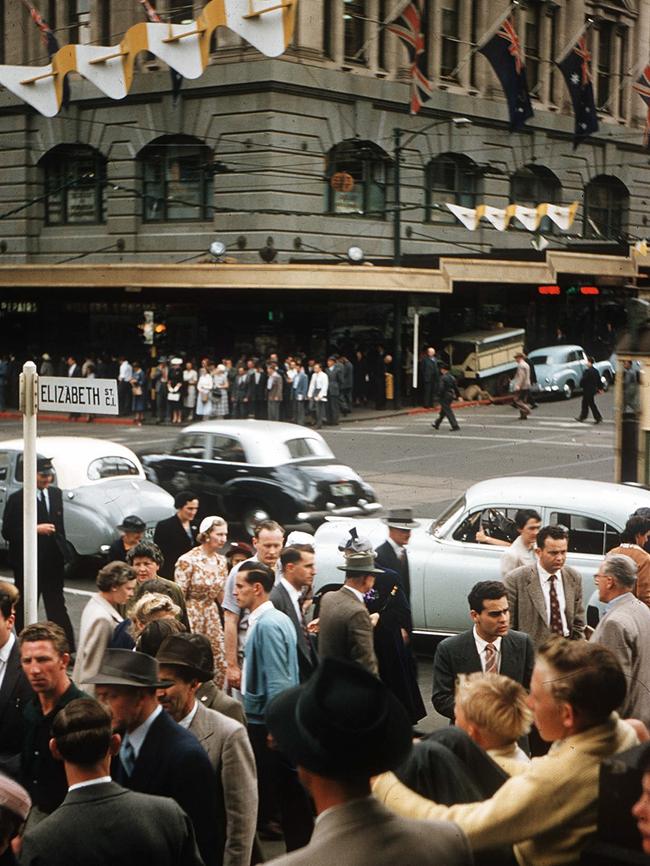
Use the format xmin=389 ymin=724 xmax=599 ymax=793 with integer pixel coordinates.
xmin=0 ymin=0 xmax=298 ymax=117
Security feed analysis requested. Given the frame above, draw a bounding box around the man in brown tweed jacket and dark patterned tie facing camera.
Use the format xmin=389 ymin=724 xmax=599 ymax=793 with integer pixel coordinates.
xmin=504 ymin=526 xmax=585 ymax=647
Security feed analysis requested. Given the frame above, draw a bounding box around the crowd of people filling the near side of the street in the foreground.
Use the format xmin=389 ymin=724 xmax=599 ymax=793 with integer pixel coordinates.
xmin=0 ymin=482 xmax=650 ymax=866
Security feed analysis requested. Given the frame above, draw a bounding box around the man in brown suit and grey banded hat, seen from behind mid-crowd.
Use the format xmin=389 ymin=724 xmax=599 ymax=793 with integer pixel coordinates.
xmin=318 ymin=531 xmax=382 ymax=676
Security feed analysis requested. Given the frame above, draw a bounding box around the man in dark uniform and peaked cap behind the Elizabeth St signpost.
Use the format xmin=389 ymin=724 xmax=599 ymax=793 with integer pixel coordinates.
xmin=2 ymin=457 xmax=75 ymax=652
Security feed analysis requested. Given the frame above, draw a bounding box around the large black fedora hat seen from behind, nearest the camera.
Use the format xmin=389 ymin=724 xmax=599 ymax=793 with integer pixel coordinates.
xmin=266 ymin=658 xmax=412 ymax=779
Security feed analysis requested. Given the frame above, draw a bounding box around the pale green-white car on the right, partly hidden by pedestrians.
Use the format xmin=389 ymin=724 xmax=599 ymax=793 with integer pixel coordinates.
xmin=315 ymin=477 xmax=650 ymax=634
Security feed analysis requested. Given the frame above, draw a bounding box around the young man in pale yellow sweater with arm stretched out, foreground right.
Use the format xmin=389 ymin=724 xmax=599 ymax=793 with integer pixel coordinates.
xmin=374 ymin=637 xmax=638 ymax=866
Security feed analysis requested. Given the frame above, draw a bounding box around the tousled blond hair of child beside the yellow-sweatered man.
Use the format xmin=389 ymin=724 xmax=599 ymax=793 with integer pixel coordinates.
xmin=456 ymin=672 xmax=533 ymax=743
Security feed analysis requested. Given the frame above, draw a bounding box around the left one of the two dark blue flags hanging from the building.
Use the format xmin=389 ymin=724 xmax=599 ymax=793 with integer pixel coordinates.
xmin=478 ymin=18 xmax=534 ymax=129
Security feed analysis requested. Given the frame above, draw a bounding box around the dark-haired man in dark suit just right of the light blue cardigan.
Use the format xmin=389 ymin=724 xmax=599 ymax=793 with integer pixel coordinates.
xmin=269 ymin=544 xmax=318 ymax=683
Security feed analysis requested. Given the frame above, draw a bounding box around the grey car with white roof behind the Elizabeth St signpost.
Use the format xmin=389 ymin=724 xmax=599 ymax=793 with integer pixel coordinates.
xmin=0 ymin=436 xmax=174 ymax=556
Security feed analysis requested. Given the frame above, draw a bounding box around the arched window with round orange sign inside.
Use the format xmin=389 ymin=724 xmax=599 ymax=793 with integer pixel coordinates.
xmin=326 ymin=139 xmax=390 ymax=219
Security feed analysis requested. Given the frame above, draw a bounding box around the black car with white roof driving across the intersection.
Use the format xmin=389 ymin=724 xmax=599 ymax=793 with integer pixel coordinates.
xmin=141 ymin=420 xmax=381 ymax=533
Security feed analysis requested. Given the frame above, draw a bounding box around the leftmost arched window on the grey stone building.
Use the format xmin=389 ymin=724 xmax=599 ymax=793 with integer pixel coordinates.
xmin=41 ymin=144 xmax=106 ymax=225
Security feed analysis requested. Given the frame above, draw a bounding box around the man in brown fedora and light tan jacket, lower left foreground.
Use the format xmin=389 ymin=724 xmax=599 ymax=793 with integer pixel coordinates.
xmin=156 ymin=634 xmax=257 ymax=866
